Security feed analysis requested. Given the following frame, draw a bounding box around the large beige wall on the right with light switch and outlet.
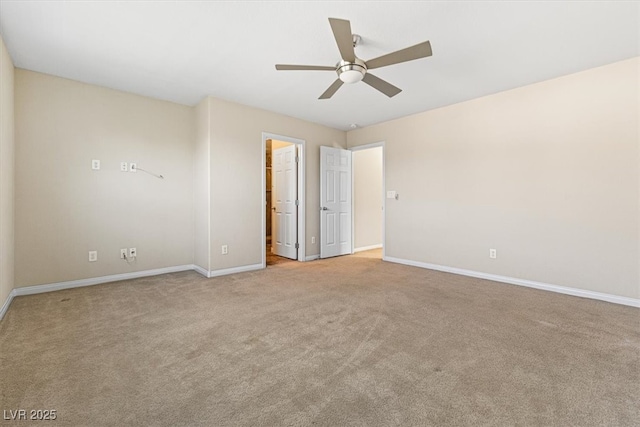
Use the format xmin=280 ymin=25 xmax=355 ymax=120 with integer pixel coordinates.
xmin=347 ymin=58 xmax=640 ymax=298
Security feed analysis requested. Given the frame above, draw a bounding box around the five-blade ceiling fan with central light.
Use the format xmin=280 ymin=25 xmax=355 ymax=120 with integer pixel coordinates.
xmin=276 ymin=18 xmax=432 ymax=99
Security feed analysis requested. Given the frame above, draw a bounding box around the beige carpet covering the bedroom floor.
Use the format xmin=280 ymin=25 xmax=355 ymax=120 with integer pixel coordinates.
xmin=0 ymin=254 xmax=640 ymax=426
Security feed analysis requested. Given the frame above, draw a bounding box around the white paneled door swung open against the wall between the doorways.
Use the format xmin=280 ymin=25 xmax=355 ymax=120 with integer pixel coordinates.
xmin=320 ymin=147 xmax=351 ymax=258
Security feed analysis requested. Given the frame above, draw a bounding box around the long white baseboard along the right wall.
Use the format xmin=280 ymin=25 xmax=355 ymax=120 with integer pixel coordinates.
xmin=382 ymin=256 xmax=640 ymax=308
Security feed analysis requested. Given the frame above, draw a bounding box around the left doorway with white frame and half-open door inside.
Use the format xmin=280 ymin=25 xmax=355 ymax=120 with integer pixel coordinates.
xmin=262 ymin=133 xmax=305 ymax=268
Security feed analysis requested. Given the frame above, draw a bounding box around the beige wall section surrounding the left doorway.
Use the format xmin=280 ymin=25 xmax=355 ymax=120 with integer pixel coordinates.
xmin=210 ymin=98 xmax=346 ymax=270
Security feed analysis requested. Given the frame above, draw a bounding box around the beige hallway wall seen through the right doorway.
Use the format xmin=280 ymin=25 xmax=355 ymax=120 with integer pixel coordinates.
xmin=352 ymin=147 xmax=383 ymax=250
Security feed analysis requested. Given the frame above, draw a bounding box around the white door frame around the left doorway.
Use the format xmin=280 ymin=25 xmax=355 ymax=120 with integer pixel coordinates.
xmin=260 ymin=132 xmax=307 ymax=268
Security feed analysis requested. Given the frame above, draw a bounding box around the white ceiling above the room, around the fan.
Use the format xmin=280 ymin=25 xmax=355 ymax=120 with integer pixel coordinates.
xmin=0 ymin=0 xmax=640 ymax=130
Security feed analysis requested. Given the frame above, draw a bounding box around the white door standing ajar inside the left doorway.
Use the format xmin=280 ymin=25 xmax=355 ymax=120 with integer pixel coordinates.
xmin=271 ymin=144 xmax=298 ymax=259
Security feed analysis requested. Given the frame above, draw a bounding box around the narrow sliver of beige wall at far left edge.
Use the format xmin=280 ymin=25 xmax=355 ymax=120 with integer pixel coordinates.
xmin=0 ymin=38 xmax=14 ymax=307
